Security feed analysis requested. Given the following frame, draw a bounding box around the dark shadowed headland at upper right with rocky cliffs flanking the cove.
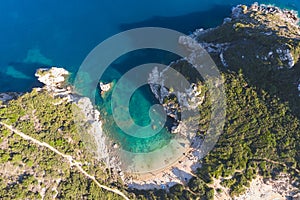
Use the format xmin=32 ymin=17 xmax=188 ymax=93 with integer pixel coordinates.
xmin=149 ymin=4 xmax=300 ymax=124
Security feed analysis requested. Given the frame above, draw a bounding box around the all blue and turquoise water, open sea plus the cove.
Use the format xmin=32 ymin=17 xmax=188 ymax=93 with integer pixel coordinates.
xmin=0 ymin=0 xmax=300 ymax=158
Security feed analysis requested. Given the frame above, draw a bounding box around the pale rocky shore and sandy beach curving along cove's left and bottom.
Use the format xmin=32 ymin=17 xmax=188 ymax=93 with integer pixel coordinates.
xmin=30 ymin=67 xmax=205 ymax=190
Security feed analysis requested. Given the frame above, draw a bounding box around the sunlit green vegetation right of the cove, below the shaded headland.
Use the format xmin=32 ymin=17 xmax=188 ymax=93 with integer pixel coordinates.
xmin=192 ymin=72 xmax=300 ymax=195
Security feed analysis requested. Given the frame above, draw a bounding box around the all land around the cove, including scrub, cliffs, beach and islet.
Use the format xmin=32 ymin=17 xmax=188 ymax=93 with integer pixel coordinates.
xmin=0 ymin=3 xmax=300 ymax=200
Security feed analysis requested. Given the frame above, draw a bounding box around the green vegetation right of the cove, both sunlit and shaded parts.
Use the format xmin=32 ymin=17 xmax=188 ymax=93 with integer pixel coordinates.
xmin=183 ymin=4 xmax=300 ymax=196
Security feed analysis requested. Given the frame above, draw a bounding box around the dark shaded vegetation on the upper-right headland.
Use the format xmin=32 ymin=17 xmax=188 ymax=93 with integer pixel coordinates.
xmin=197 ymin=6 xmax=300 ymax=117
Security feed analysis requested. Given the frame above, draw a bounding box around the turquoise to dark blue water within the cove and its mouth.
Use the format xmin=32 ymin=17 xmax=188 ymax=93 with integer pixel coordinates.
xmin=96 ymin=49 xmax=178 ymax=153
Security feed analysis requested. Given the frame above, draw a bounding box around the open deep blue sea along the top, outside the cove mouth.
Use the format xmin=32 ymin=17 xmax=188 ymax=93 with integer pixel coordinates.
xmin=0 ymin=0 xmax=300 ymax=92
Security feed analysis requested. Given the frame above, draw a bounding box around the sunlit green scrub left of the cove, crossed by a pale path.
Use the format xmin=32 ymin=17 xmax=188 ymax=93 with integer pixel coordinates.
xmin=0 ymin=91 xmax=127 ymax=199
